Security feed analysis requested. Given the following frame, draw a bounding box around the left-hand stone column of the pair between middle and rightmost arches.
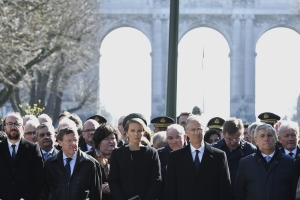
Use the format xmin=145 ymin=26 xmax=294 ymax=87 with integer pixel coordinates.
xmin=230 ymin=15 xmax=244 ymax=117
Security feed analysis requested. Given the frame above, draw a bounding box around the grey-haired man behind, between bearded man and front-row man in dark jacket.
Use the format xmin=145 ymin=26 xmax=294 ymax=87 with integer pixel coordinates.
xmin=37 ymin=122 xmax=59 ymax=161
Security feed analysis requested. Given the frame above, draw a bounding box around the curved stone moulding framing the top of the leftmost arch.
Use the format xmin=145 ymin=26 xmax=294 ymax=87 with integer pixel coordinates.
xmin=98 ymin=21 xmax=153 ymax=51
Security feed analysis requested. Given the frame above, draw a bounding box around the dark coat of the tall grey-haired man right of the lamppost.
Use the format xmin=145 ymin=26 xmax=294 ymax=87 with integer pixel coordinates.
xmin=164 ymin=143 xmax=230 ymax=200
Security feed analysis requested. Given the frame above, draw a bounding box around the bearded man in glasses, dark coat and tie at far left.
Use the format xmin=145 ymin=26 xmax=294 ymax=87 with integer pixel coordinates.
xmin=0 ymin=112 xmax=44 ymax=200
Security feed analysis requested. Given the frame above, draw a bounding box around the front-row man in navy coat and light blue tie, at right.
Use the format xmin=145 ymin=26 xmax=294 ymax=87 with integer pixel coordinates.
xmin=235 ymin=124 xmax=298 ymax=200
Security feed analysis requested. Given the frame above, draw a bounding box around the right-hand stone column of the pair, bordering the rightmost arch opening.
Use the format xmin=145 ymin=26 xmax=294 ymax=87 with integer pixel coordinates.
xmin=244 ymin=15 xmax=256 ymax=122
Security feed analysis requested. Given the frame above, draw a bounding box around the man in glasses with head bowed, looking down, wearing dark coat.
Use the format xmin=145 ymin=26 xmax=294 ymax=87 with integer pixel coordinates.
xmin=213 ymin=117 xmax=256 ymax=200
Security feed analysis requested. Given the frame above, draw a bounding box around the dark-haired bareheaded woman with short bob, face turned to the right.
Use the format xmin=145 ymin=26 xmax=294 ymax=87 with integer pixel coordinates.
xmin=87 ymin=124 xmax=118 ymax=200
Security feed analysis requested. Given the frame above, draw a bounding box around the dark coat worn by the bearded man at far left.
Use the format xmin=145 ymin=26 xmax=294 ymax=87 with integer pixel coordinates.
xmin=0 ymin=138 xmax=44 ymax=200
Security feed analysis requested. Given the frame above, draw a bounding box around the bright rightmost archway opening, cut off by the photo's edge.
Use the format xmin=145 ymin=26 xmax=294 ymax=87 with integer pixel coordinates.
xmin=255 ymin=28 xmax=300 ymax=118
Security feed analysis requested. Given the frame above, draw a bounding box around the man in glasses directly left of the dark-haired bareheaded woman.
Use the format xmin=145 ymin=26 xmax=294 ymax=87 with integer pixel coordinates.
xmin=79 ymin=119 xmax=100 ymax=152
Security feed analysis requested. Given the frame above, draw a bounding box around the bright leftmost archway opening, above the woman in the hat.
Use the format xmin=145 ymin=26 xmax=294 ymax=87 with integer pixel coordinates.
xmin=100 ymin=27 xmax=151 ymax=120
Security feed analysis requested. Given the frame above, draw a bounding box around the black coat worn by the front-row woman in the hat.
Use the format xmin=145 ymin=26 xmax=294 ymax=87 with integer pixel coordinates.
xmin=108 ymin=145 xmax=161 ymax=200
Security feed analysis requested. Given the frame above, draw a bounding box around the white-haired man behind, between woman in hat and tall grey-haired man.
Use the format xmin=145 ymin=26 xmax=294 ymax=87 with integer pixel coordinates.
xmin=157 ymin=124 xmax=186 ymax=199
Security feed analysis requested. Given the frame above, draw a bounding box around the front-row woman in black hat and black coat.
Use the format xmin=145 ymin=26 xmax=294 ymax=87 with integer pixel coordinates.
xmin=108 ymin=118 xmax=161 ymax=200
